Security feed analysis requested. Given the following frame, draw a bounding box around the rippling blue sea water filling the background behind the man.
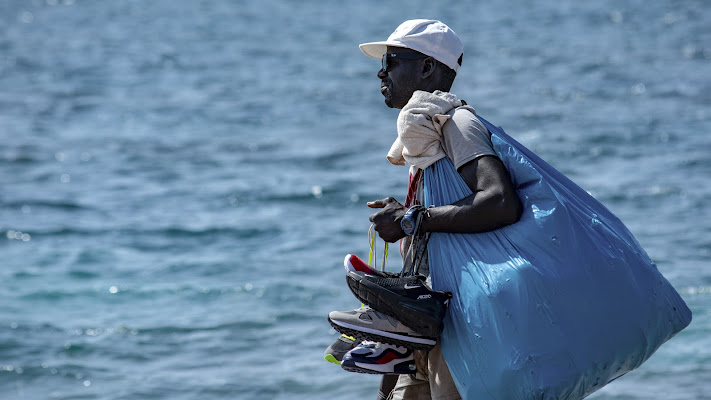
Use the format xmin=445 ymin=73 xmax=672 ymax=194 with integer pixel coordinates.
xmin=0 ymin=0 xmax=711 ymax=400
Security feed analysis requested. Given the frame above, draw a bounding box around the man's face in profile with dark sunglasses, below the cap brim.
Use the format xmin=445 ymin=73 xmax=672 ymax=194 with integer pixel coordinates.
xmin=378 ymin=47 xmax=424 ymax=108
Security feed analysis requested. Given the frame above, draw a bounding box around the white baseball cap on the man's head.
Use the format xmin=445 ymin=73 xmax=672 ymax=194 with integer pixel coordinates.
xmin=359 ymin=19 xmax=464 ymax=72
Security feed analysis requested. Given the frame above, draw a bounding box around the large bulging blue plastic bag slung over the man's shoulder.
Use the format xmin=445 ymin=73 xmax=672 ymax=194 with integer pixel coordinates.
xmin=424 ymin=117 xmax=691 ymax=400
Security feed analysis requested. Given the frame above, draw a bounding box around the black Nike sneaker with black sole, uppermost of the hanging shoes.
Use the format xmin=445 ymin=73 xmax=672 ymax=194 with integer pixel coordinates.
xmin=346 ymin=271 xmax=452 ymax=338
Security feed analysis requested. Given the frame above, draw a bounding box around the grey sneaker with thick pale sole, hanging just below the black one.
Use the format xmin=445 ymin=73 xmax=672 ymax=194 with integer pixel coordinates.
xmin=328 ymin=306 xmax=437 ymax=350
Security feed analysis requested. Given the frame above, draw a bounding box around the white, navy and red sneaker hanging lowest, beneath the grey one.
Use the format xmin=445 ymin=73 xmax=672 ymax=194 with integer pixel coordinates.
xmin=341 ymin=341 xmax=417 ymax=374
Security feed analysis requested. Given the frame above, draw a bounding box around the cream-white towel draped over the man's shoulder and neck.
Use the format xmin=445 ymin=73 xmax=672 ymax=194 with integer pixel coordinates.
xmin=387 ymin=90 xmax=474 ymax=169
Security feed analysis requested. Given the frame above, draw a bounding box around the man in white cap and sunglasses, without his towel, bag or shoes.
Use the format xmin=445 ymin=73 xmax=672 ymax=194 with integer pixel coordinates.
xmin=360 ymin=20 xmax=521 ymax=400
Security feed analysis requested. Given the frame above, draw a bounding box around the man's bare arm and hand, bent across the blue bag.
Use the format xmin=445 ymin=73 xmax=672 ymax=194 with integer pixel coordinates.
xmin=368 ymin=156 xmax=522 ymax=242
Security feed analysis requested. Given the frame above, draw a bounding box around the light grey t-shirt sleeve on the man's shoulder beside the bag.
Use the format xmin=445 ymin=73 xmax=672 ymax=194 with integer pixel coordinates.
xmin=442 ymin=108 xmax=496 ymax=169
